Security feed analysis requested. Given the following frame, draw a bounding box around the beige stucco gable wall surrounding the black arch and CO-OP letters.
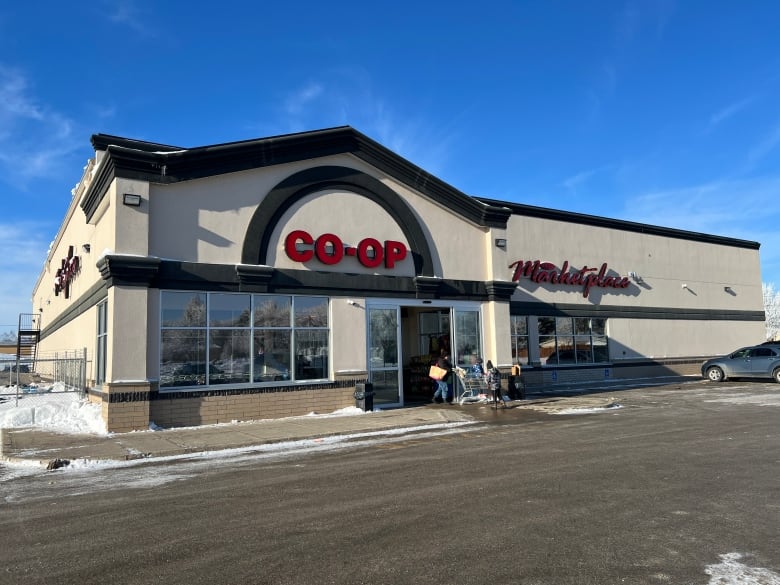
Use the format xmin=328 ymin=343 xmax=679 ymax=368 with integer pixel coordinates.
xmin=149 ymin=155 xmax=494 ymax=280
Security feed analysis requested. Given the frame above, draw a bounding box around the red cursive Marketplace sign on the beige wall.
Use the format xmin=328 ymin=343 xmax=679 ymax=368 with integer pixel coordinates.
xmin=509 ymin=260 xmax=631 ymax=298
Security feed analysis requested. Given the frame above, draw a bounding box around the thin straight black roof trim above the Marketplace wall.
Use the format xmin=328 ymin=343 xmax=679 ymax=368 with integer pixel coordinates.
xmin=477 ymin=197 xmax=761 ymax=250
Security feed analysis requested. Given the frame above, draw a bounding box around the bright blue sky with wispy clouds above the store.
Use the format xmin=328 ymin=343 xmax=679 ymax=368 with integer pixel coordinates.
xmin=0 ymin=0 xmax=780 ymax=332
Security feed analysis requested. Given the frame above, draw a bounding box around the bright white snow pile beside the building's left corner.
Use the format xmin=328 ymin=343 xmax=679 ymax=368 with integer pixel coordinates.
xmin=0 ymin=384 xmax=108 ymax=435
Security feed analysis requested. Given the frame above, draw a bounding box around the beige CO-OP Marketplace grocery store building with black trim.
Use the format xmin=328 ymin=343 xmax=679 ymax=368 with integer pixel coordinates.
xmin=33 ymin=127 xmax=764 ymax=431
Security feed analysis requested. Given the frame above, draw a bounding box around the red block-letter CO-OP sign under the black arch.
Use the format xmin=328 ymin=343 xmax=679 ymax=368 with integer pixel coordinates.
xmin=284 ymin=230 xmax=407 ymax=268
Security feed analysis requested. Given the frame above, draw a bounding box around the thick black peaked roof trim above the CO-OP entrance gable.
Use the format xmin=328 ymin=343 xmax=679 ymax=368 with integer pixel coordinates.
xmin=82 ymin=126 xmax=511 ymax=228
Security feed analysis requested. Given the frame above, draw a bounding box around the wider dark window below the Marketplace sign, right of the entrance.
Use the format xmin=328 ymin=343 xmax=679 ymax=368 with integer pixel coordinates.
xmin=538 ymin=317 xmax=609 ymax=365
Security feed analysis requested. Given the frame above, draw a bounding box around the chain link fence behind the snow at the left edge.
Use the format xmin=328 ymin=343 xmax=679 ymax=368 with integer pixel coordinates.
xmin=0 ymin=349 xmax=87 ymax=404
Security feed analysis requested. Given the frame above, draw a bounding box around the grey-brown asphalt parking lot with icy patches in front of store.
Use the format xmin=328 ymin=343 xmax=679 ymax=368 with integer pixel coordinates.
xmin=0 ymin=382 xmax=780 ymax=585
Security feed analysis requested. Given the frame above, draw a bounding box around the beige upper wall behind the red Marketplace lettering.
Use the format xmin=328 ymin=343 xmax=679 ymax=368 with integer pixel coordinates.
xmin=506 ymin=216 xmax=763 ymax=311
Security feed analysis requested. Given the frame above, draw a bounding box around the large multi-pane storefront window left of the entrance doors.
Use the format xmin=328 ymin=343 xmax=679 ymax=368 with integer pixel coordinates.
xmin=160 ymin=291 xmax=330 ymax=388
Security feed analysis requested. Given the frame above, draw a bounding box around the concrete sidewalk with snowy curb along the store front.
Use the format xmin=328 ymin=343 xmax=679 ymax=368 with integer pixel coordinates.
xmin=0 ymin=393 xmax=616 ymax=469
